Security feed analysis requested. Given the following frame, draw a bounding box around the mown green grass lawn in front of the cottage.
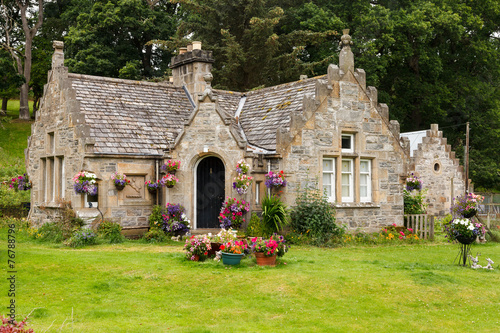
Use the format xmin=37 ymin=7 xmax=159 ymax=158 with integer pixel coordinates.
xmin=0 ymin=223 xmax=500 ymax=332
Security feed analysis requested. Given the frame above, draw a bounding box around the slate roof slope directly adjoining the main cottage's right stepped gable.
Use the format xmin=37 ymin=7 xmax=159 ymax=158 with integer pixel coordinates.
xmin=240 ymin=76 xmax=325 ymax=150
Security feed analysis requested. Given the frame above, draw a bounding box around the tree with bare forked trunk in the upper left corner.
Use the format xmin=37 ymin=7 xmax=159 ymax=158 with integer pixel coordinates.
xmin=0 ymin=0 xmax=43 ymax=120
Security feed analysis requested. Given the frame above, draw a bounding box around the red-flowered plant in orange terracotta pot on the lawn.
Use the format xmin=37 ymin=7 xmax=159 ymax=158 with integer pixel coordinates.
xmin=250 ymin=234 xmax=288 ymax=266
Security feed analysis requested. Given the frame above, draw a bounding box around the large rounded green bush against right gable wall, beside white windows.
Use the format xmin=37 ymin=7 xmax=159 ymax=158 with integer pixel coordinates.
xmin=290 ymin=184 xmax=344 ymax=243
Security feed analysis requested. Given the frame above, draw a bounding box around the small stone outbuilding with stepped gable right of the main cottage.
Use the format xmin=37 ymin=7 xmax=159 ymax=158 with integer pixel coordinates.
xmin=401 ymin=124 xmax=465 ymax=216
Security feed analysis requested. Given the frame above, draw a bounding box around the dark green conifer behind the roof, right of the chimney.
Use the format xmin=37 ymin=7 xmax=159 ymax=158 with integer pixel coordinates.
xmin=171 ymin=0 xmax=336 ymax=91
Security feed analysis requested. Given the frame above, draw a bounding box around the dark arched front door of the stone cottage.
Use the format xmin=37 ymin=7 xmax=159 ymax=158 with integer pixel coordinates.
xmin=196 ymin=156 xmax=225 ymax=228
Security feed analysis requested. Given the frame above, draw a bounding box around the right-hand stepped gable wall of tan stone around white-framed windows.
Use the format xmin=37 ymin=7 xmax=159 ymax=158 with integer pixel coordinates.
xmin=277 ymin=65 xmax=404 ymax=230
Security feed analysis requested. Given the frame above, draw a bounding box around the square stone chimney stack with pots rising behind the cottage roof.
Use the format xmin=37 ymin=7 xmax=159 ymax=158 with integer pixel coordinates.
xmin=170 ymin=42 xmax=214 ymax=96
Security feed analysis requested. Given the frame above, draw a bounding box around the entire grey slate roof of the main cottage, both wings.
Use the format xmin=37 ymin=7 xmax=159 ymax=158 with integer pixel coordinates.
xmin=69 ymin=74 xmax=324 ymax=155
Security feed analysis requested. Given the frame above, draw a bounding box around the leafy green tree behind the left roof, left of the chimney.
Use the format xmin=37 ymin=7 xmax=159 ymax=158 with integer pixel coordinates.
xmin=65 ymin=0 xmax=176 ymax=78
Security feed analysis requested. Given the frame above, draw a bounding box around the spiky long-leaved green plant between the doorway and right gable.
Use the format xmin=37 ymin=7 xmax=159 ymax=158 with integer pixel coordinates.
xmin=262 ymin=195 xmax=289 ymax=234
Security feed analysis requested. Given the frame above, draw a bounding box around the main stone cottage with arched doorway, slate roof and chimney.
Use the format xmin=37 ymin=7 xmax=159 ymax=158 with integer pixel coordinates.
xmin=26 ymin=31 xmax=409 ymax=232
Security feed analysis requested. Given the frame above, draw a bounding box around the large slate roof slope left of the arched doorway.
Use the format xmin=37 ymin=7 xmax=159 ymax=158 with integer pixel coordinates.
xmin=69 ymin=74 xmax=193 ymax=155
